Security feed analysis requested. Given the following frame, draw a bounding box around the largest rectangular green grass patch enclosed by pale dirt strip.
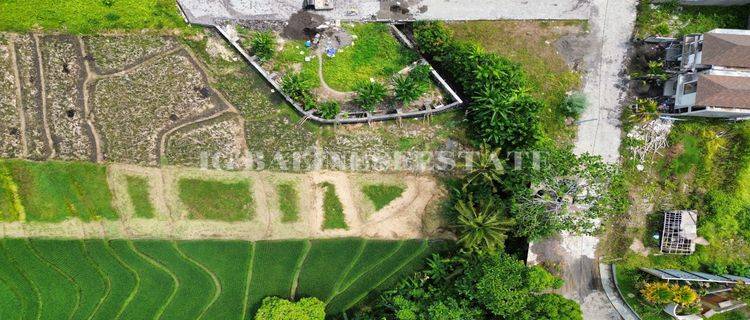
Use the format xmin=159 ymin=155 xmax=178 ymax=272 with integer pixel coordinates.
xmin=179 ymin=179 xmax=254 ymax=221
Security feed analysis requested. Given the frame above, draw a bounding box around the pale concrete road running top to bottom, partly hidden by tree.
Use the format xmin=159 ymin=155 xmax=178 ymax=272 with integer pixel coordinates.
xmin=529 ymin=0 xmax=637 ymax=320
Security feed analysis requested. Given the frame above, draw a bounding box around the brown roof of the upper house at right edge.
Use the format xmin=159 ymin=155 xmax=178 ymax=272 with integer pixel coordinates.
xmin=701 ymin=29 xmax=750 ymax=68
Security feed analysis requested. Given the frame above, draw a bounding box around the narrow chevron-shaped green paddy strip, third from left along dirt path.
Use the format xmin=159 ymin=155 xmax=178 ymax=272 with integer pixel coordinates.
xmin=83 ymin=240 xmax=138 ymax=320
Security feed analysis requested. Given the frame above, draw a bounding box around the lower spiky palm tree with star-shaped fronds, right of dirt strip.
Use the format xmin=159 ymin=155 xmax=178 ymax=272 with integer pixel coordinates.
xmin=454 ymin=197 xmax=515 ymax=251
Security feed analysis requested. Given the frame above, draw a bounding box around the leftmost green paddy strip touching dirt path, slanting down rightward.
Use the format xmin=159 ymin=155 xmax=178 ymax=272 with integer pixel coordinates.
xmin=3 ymin=239 xmax=79 ymax=319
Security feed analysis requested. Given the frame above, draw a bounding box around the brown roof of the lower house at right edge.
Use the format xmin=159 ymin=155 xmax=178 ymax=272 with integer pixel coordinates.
xmin=695 ymin=74 xmax=750 ymax=109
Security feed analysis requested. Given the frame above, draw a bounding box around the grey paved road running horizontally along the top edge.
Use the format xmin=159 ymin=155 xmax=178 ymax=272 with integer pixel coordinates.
xmin=178 ymin=0 xmax=590 ymax=24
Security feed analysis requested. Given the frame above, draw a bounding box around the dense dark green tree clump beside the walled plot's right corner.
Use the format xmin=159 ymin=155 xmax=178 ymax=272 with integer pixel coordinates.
xmin=414 ymin=22 xmax=542 ymax=152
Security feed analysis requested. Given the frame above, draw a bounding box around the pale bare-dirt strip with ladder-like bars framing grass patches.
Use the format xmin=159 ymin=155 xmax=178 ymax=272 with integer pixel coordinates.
xmin=0 ymin=165 xmax=443 ymax=241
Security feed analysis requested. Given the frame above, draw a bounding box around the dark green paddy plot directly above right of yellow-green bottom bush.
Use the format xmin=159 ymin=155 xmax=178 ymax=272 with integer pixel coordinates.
xmin=296 ymin=239 xmax=365 ymax=301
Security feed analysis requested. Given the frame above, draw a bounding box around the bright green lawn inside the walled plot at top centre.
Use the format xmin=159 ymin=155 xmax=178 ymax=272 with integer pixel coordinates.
xmin=323 ymin=23 xmax=419 ymax=91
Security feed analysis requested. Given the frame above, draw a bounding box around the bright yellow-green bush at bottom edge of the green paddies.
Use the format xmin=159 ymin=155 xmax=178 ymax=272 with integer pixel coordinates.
xmin=255 ymin=297 xmax=326 ymax=320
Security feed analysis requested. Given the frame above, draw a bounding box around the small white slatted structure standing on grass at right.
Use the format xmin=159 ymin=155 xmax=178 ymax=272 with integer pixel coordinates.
xmin=661 ymin=210 xmax=698 ymax=254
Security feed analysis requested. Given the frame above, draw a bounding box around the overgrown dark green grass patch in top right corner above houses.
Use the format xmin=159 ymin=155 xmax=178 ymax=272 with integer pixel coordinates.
xmin=636 ymin=0 xmax=750 ymax=38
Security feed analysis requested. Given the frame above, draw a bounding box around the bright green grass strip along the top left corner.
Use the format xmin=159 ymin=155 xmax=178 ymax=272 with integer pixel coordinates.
xmin=0 ymin=0 xmax=188 ymax=34
